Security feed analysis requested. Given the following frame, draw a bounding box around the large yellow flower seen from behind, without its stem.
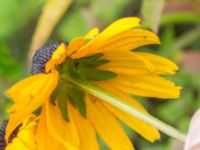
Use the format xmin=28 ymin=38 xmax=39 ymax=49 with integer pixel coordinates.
xmin=6 ymin=17 xmax=180 ymax=150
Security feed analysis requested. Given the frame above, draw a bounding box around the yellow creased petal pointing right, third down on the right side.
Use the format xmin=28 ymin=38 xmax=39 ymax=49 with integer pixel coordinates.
xmin=100 ymin=51 xmax=178 ymax=75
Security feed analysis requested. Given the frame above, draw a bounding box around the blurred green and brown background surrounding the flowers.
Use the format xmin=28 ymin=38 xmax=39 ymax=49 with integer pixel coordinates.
xmin=0 ymin=0 xmax=200 ymax=150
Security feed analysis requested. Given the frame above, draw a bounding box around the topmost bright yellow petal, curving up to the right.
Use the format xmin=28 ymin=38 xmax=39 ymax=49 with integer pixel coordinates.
xmin=72 ymin=17 xmax=140 ymax=58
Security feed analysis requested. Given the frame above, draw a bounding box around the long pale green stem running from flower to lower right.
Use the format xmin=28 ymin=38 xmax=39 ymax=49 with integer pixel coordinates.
xmin=70 ymin=78 xmax=186 ymax=142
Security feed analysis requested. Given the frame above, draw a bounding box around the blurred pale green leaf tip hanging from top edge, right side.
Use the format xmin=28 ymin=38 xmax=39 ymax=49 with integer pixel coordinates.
xmin=142 ymin=0 xmax=165 ymax=33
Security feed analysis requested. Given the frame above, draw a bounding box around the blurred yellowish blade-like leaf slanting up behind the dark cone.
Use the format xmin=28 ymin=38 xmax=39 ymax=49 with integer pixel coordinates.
xmin=29 ymin=0 xmax=72 ymax=61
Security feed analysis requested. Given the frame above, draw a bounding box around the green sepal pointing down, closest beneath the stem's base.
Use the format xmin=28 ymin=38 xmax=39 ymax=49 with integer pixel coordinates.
xmin=68 ymin=86 xmax=87 ymax=117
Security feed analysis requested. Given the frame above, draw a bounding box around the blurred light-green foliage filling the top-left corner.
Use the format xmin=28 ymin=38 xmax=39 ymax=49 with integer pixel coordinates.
xmin=0 ymin=0 xmax=43 ymax=39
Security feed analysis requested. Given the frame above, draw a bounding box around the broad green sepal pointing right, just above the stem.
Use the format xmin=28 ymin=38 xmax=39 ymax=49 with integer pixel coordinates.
xmin=78 ymin=67 xmax=117 ymax=81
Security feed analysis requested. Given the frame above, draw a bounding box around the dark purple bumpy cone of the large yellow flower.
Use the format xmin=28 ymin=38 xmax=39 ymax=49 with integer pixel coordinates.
xmin=31 ymin=42 xmax=67 ymax=74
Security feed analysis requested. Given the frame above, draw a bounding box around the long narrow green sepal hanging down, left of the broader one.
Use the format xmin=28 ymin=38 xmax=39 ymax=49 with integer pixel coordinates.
xmin=57 ymin=86 xmax=69 ymax=121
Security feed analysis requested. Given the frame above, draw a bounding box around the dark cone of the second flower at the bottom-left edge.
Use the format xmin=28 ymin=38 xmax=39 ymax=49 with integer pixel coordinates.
xmin=0 ymin=120 xmax=8 ymax=150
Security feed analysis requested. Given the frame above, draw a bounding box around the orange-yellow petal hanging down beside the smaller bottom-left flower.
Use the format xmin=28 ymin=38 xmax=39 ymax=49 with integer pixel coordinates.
xmin=36 ymin=107 xmax=72 ymax=150
